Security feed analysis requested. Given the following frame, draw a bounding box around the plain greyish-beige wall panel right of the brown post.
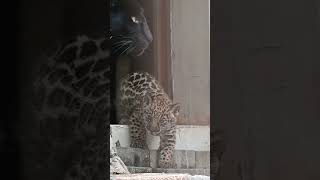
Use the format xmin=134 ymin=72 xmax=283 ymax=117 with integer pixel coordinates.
xmin=171 ymin=0 xmax=210 ymax=125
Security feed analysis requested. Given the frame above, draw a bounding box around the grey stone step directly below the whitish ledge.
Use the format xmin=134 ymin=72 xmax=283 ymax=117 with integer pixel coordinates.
xmin=117 ymin=147 xmax=210 ymax=169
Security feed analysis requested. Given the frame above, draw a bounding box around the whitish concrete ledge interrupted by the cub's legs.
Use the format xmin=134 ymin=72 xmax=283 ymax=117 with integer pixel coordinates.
xmin=111 ymin=125 xmax=210 ymax=151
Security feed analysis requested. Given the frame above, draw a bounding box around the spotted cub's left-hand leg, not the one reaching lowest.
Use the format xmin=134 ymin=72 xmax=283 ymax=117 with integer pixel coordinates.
xmin=129 ymin=114 xmax=147 ymax=149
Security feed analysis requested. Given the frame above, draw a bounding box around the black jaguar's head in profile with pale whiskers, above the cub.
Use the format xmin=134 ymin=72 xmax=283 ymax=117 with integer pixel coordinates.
xmin=110 ymin=0 xmax=153 ymax=56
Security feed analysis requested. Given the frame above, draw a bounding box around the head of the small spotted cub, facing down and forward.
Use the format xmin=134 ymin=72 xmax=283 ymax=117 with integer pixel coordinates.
xmin=143 ymin=95 xmax=180 ymax=136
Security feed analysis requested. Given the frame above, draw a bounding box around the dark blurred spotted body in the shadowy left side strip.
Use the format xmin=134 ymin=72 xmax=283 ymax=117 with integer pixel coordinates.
xmin=33 ymin=36 xmax=111 ymax=179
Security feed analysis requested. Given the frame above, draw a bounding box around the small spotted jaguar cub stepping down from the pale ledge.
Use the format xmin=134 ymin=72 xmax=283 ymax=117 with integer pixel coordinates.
xmin=119 ymin=72 xmax=180 ymax=168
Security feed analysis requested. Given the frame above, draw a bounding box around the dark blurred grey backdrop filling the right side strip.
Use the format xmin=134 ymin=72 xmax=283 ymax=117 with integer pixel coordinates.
xmin=211 ymin=0 xmax=320 ymax=180
